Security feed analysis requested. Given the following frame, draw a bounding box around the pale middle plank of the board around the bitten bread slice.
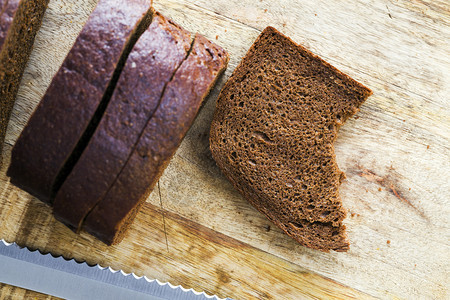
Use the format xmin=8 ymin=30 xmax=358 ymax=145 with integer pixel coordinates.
xmin=149 ymin=1 xmax=450 ymax=298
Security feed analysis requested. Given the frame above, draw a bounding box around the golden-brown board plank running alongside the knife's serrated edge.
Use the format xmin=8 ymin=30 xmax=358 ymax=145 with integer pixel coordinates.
xmin=0 ymin=165 xmax=371 ymax=299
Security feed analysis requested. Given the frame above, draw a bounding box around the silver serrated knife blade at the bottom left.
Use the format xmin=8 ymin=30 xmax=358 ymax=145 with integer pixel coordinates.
xmin=0 ymin=240 xmax=229 ymax=300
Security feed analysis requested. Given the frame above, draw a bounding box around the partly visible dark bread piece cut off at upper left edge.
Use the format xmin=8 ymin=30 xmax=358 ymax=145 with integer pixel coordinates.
xmin=0 ymin=0 xmax=48 ymax=166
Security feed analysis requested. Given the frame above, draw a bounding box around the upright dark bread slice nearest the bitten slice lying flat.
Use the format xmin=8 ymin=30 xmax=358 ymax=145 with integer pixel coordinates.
xmin=83 ymin=34 xmax=228 ymax=244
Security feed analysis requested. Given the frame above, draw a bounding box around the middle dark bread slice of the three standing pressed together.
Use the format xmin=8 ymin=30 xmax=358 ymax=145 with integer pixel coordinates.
xmin=53 ymin=13 xmax=191 ymax=231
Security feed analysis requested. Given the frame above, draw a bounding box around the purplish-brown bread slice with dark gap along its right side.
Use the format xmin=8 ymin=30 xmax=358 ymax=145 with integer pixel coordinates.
xmin=8 ymin=0 xmax=151 ymax=204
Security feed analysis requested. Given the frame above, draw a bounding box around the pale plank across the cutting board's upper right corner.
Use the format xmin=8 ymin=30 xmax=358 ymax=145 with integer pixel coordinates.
xmin=185 ymin=0 xmax=450 ymax=104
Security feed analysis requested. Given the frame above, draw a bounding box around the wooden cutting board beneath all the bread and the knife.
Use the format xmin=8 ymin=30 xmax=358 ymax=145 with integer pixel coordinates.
xmin=0 ymin=0 xmax=450 ymax=299
